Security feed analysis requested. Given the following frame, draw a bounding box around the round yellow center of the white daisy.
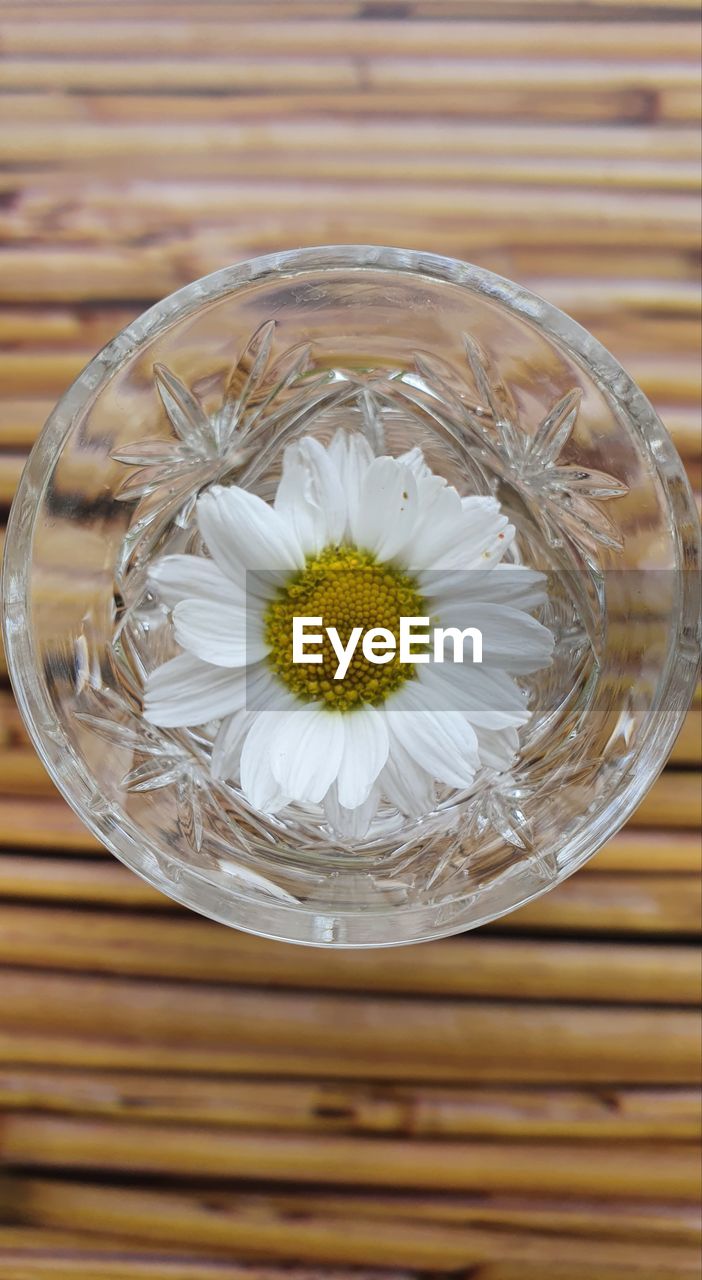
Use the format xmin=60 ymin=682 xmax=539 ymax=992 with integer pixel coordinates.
xmin=264 ymin=547 xmax=427 ymax=710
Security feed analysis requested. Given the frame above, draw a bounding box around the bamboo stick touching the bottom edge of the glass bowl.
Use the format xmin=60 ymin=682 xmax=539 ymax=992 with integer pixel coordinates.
xmin=0 ymin=906 xmax=701 ymax=1006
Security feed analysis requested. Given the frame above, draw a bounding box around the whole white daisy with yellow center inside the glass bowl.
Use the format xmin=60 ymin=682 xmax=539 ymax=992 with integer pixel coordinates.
xmin=143 ymin=431 xmax=553 ymax=835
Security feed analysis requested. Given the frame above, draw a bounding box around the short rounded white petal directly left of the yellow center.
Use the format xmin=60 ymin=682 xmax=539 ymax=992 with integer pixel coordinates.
xmin=173 ymin=600 xmax=268 ymax=667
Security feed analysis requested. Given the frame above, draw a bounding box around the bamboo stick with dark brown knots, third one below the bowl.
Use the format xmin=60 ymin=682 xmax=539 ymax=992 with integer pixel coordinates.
xmin=0 ymin=1068 xmax=701 ymax=1141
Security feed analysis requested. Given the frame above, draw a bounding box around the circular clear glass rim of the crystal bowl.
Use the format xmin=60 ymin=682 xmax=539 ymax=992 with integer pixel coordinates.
xmin=1 ymin=244 xmax=702 ymax=947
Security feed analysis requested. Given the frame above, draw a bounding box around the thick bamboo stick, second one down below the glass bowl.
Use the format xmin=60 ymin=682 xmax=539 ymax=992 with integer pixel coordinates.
xmin=0 ymin=969 xmax=699 ymax=1084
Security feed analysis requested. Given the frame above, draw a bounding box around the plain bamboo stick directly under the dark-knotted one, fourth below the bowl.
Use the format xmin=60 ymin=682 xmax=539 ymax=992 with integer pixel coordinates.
xmin=0 ymin=1114 xmax=699 ymax=1198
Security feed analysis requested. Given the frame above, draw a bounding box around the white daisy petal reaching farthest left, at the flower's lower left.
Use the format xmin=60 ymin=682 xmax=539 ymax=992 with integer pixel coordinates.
xmin=143 ymin=653 xmax=247 ymax=728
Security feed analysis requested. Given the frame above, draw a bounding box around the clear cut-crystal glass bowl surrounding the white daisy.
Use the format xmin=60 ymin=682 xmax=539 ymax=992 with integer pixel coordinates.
xmin=4 ymin=246 xmax=699 ymax=947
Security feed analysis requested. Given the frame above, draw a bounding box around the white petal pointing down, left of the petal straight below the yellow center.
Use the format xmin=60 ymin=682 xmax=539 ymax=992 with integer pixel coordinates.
xmin=266 ymin=703 xmax=345 ymax=804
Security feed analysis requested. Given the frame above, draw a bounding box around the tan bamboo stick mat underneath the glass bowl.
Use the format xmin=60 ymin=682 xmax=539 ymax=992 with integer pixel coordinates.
xmin=0 ymin=0 xmax=702 ymax=1280
